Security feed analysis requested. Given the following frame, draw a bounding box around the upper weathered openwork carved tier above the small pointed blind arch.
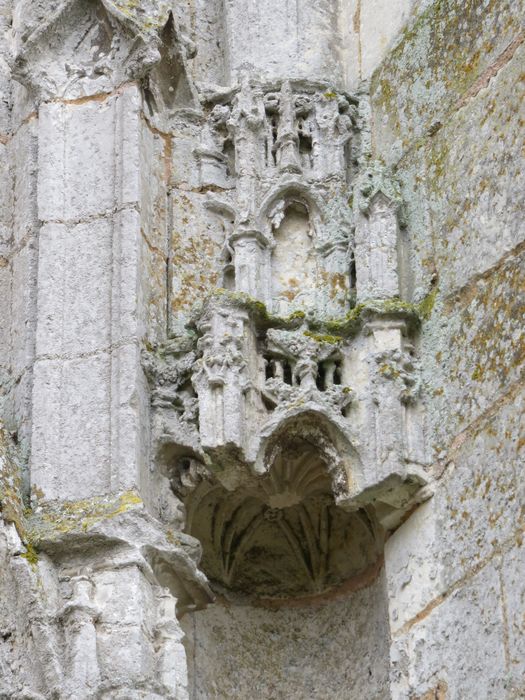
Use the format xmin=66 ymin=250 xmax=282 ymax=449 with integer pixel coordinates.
xmin=197 ymin=76 xmax=357 ymax=190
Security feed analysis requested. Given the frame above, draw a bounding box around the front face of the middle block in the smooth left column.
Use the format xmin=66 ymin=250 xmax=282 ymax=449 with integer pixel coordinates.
xmin=36 ymin=219 xmax=112 ymax=356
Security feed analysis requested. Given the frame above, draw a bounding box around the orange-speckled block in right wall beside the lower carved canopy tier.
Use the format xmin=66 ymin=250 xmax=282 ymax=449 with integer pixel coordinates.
xmin=422 ymin=252 xmax=525 ymax=455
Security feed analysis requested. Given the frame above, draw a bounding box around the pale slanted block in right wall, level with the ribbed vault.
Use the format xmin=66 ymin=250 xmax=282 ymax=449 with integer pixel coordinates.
xmin=385 ymin=386 xmax=525 ymax=620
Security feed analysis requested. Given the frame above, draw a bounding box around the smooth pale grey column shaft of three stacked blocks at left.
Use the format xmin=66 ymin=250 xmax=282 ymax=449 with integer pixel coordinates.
xmin=31 ymin=85 xmax=145 ymax=499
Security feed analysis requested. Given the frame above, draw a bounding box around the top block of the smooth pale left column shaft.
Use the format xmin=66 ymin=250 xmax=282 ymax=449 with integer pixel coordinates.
xmin=38 ymin=87 xmax=140 ymax=221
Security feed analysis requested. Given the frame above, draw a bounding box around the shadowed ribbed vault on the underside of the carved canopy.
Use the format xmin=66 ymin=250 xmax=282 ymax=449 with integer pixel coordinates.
xmin=180 ymin=414 xmax=383 ymax=602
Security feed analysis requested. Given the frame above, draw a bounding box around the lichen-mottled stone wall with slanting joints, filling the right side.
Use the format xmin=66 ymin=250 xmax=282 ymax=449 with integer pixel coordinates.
xmin=371 ymin=0 xmax=525 ymax=699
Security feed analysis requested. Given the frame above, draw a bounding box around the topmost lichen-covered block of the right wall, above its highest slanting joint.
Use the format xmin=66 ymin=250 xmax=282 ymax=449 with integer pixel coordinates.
xmin=371 ymin=0 xmax=524 ymax=162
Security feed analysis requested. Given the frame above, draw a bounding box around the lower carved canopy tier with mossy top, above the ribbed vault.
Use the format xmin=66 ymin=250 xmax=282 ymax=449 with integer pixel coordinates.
xmin=145 ymin=293 xmax=426 ymax=536
